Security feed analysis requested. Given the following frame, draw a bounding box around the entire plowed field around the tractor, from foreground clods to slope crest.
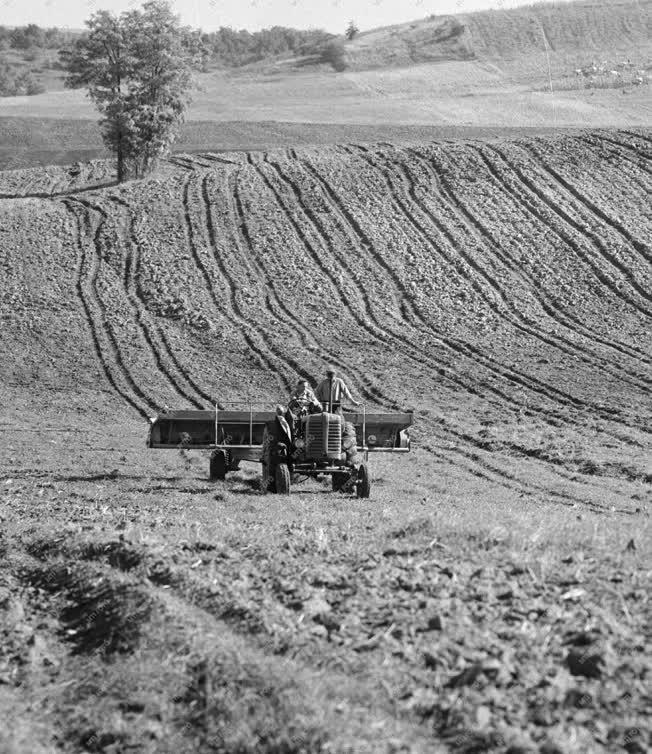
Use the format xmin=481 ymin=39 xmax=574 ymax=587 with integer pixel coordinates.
xmin=0 ymin=131 xmax=652 ymax=754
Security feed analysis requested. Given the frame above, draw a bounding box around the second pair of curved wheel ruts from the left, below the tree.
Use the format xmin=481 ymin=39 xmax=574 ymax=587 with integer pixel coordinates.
xmin=103 ymin=196 xmax=215 ymax=409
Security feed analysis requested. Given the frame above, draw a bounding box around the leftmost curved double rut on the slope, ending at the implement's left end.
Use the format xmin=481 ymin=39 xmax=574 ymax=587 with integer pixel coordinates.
xmin=62 ymin=200 xmax=149 ymax=421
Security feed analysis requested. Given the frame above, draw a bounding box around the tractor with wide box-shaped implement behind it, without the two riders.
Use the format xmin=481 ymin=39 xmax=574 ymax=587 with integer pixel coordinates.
xmin=147 ymin=402 xmax=413 ymax=497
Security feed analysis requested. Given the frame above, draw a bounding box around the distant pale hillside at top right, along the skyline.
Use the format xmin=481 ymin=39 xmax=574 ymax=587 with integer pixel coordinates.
xmin=334 ymin=0 xmax=652 ymax=69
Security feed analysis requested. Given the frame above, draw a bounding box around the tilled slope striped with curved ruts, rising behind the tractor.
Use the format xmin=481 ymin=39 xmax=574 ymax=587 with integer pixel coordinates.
xmin=0 ymin=133 xmax=652 ymax=497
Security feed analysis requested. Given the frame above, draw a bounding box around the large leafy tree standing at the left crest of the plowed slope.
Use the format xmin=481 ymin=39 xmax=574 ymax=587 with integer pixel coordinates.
xmin=61 ymin=0 xmax=204 ymax=181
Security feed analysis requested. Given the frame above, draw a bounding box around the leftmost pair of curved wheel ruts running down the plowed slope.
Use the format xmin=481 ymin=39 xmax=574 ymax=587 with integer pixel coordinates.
xmin=62 ymin=200 xmax=150 ymax=421
